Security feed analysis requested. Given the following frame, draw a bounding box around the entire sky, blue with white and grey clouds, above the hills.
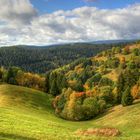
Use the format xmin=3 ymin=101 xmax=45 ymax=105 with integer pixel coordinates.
xmin=0 ymin=0 xmax=140 ymax=46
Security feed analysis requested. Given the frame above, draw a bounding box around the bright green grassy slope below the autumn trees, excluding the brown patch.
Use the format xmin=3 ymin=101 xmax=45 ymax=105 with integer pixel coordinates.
xmin=0 ymin=85 xmax=140 ymax=140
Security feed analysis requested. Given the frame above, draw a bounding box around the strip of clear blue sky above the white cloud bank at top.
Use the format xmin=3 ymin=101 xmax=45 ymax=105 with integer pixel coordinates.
xmin=31 ymin=0 xmax=140 ymax=14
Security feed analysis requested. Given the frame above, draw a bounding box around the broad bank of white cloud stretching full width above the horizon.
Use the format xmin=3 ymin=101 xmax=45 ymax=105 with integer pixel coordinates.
xmin=0 ymin=0 xmax=140 ymax=45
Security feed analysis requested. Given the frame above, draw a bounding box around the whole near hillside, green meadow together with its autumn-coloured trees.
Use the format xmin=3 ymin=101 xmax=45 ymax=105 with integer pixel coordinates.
xmin=0 ymin=43 xmax=140 ymax=140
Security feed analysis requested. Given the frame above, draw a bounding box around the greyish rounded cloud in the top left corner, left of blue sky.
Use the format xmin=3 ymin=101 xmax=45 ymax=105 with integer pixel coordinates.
xmin=0 ymin=0 xmax=37 ymax=24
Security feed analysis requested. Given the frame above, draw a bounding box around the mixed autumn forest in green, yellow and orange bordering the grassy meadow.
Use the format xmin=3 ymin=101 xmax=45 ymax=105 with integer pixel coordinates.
xmin=0 ymin=42 xmax=140 ymax=121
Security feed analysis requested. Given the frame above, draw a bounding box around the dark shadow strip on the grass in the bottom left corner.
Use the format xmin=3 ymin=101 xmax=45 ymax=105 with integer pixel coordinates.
xmin=0 ymin=132 xmax=36 ymax=140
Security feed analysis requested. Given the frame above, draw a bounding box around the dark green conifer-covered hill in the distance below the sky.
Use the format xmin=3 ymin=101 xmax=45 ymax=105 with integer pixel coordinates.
xmin=0 ymin=43 xmax=131 ymax=73
